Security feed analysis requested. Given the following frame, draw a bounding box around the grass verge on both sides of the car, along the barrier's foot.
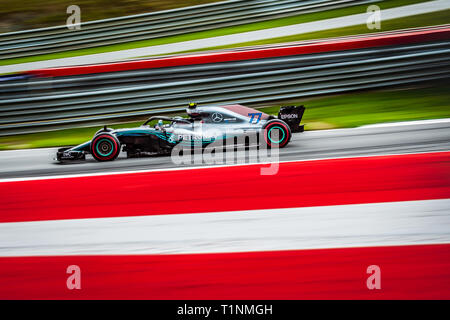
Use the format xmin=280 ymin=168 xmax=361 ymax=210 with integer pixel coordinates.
xmin=0 ymin=84 xmax=450 ymax=150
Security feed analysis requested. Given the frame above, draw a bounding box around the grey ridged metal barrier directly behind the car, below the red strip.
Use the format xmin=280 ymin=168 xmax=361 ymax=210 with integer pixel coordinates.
xmin=0 ymin=26 xmax=450 ymax=135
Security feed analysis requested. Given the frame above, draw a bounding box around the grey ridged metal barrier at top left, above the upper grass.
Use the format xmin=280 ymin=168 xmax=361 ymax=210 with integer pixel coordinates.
xmin=0 ymin=0 xmax=372 ymax=59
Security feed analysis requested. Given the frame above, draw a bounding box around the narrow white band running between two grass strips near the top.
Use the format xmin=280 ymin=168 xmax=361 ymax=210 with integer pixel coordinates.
xmin=0 ymin=0 xmax=450 ymax=74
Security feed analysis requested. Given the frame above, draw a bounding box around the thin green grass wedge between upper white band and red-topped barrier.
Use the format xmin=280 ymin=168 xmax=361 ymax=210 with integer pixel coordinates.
xmin=169 ymin=9 xmax=450 ymax=53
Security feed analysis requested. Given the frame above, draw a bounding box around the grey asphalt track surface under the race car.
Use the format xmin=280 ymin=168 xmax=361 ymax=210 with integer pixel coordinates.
xmin=0 ymin=119 xmax=450 ymax=180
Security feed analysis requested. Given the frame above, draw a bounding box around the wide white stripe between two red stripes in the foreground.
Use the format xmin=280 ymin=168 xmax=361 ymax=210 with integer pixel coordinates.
xmin=0 ymin=199 xmax=450 ymax=256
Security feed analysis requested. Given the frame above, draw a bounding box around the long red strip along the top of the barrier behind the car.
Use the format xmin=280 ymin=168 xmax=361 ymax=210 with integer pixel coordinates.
xmin=28 ymin=27 xmax=450 ymax=77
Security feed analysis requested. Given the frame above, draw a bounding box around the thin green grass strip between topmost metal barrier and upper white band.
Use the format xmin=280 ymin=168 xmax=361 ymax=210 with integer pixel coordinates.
xmin=0 ymin=0 xmax=429 ymax=65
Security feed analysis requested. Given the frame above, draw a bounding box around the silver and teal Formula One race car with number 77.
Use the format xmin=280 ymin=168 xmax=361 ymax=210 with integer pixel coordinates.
xmin=56 ymin=103 xmax=305 ymax=162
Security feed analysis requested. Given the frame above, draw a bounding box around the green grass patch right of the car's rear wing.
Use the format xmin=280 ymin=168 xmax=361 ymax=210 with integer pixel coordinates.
xmin=261 ymin=85 xmax=450 ymax=130
